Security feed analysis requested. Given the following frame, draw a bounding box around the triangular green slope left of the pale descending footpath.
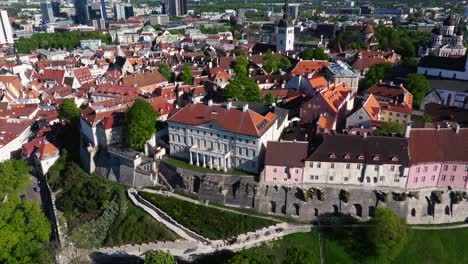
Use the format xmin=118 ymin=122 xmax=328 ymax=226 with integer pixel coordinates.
xmin=104 ymin=202 xmax=178 ymax=247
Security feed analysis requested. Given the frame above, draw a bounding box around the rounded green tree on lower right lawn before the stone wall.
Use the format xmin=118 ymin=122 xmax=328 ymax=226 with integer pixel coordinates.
xmin=367 ymin=208 xmax=409 ymax=262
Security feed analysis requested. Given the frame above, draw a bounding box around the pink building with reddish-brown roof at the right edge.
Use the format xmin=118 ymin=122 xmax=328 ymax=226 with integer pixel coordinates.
xmin=406 ymin=125 xmax=468 ymax=189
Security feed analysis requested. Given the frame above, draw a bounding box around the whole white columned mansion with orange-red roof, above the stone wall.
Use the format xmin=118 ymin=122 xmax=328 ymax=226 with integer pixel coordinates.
xmin=167 ymin=101 xmax=279 ymax=173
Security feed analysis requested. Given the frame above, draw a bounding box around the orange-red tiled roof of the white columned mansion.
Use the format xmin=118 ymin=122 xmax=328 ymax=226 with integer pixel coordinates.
xmin=168 ymin=103 xmax=277 ymax=137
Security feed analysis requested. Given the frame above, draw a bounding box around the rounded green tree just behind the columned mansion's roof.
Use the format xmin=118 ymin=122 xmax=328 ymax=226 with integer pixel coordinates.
xmin=223 ymin=76 xmax=262 ymax=102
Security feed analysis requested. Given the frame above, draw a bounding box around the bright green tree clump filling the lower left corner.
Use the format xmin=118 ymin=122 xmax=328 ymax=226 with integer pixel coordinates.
xmin=0 ymin=160 xmax=50 ymax=263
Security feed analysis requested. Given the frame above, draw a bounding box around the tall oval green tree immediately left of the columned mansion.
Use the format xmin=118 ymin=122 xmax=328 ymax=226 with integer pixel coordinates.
xmin=123 ymin=99 xmax=159 ymax=150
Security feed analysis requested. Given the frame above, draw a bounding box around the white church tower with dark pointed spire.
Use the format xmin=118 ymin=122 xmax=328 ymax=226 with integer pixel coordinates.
xmin=276 ymin=0 xmax=294 ymax=52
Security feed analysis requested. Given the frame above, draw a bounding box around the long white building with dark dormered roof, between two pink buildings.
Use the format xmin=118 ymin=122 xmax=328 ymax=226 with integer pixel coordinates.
xmin=303 ymin=135 xmax=409 ymax=189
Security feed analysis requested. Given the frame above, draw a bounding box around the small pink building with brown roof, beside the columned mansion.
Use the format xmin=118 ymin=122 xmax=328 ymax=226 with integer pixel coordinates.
xmin=264 ymin=141 xmax=308 ymax=184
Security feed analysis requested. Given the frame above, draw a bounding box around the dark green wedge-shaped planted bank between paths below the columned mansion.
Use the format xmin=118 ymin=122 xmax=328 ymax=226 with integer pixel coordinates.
xmin=140 ymin=192 xmax=276 ymax=239
